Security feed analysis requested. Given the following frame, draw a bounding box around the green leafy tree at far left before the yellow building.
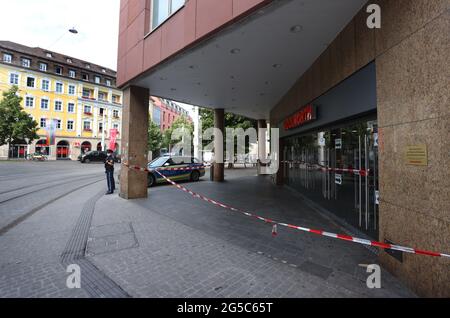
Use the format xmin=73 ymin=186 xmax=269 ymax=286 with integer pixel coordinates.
xmin=0 ymin=86 xmax=39 ymax=146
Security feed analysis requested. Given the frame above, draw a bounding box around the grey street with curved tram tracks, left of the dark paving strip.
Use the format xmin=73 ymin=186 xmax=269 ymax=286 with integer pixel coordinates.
xmin=0 ymin=162 xmax=106 ymax=297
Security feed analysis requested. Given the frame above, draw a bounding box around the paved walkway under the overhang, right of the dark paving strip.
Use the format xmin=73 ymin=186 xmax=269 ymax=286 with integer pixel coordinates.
xmin=88 ymin=176 xmax=414 ymax=297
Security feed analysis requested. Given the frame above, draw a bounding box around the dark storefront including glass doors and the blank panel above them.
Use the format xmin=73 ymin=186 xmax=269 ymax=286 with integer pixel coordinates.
xmin=280 ymin=63 xmax=378 ymax=238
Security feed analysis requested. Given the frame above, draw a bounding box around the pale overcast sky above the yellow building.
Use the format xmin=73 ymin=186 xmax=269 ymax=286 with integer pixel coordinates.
xmin=0 ymin=0 xmax=120 ymax=70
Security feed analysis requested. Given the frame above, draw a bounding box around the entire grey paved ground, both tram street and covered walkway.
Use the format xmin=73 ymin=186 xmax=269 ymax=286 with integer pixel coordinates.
xmin=0 ymin=162 xmax=414 ymax=297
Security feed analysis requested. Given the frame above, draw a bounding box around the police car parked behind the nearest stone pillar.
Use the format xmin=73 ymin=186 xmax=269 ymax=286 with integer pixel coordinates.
xmin=147 ymin=156 xmax=205 ymax=187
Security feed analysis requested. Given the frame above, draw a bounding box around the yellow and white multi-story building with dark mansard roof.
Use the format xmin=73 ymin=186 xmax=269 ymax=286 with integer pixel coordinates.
xmin=0 ymin=41 xmax=122 ymax=160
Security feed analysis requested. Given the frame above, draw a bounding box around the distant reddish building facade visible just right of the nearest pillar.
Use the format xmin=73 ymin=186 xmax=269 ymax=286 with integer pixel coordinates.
xmin=150 ymin=96 xmax=192 ymax=131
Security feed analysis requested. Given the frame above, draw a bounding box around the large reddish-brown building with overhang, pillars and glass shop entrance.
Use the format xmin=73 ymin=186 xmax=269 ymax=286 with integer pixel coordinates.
xmin=117 ymin=0 xmax=450 ymax=297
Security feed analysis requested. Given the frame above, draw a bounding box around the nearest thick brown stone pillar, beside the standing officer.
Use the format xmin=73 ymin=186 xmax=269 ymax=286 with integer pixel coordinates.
xmin=120 ymin=86 xmax=150 ymax=199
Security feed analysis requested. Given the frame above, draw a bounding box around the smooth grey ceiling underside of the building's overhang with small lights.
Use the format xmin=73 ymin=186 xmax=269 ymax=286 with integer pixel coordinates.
xmin=135 ymin=0 xmax=367 ymax=119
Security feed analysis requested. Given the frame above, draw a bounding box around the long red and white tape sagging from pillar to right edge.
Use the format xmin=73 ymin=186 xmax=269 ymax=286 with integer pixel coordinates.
xmin=121 ymin=164 xmax=450 ymax=258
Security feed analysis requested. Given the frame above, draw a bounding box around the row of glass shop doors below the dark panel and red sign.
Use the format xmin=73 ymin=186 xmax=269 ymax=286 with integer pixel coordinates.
xmin=284 ymin=115 xmax=379 ymax=238
